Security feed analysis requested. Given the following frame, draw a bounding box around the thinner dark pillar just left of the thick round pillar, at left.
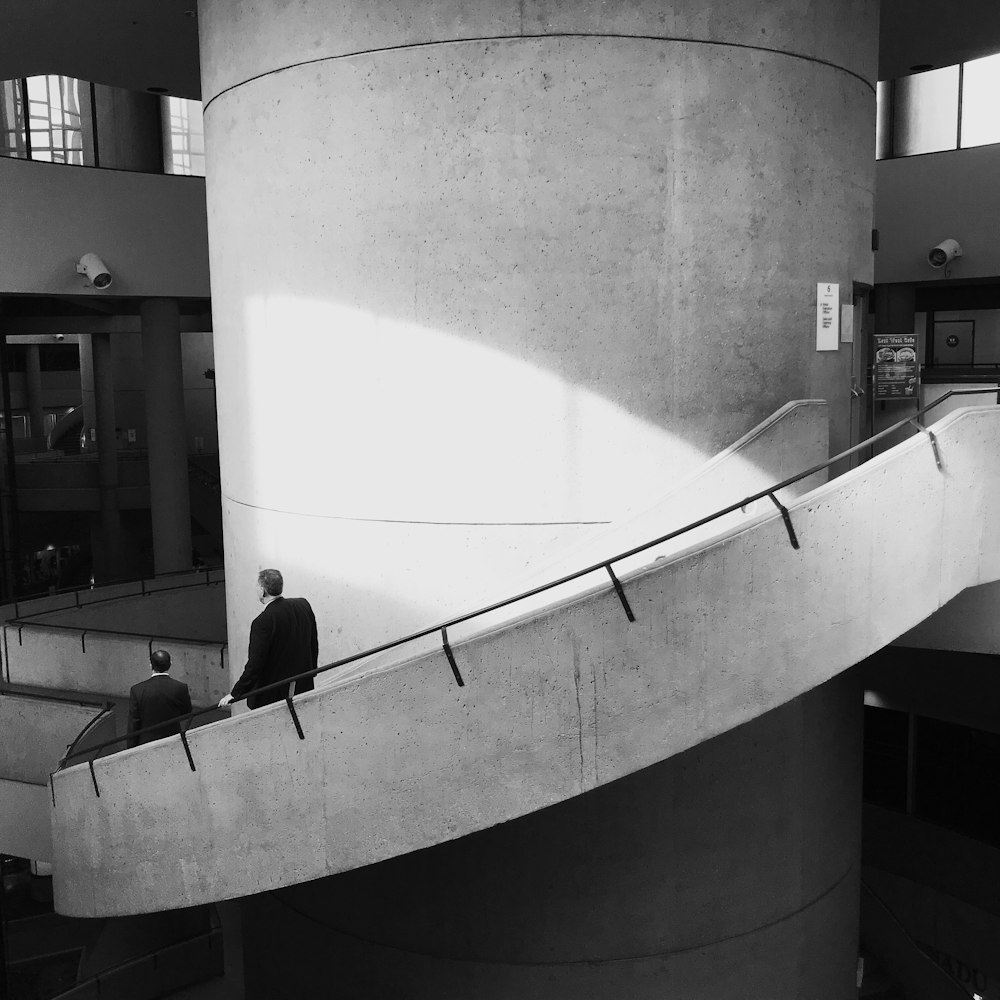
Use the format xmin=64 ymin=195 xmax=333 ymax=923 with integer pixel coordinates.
xmin=90 ymin=333 xmax=124 ymax=580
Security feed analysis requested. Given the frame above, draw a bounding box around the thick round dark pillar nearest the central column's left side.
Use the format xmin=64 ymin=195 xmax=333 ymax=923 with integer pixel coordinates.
xmin=140 ymin=299 xmax=191 ymax=574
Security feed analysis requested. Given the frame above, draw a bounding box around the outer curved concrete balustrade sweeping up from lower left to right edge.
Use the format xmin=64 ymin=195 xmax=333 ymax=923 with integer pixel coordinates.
xmin=53 ymin=407 xmax=1000 ymax=916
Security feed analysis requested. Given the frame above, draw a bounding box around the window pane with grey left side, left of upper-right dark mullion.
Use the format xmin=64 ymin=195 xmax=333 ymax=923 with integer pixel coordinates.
xmin=892 ymin=66 xmax=958 ymax=156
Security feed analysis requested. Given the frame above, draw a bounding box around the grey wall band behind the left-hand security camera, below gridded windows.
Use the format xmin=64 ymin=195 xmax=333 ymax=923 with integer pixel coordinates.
xmin=0 ymin=157 xmax=209 ymax=298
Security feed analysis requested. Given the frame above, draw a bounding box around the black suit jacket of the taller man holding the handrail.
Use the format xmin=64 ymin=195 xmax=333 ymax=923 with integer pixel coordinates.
xmin=232 ymin=597 xmax=319 ymax=708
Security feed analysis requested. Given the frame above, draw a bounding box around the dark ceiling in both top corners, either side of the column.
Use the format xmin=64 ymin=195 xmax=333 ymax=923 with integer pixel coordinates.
xmin=0 ymin=0 xmax=1000 ymax=97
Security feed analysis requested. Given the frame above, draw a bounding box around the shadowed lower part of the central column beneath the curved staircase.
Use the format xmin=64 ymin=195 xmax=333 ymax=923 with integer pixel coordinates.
xmin=241 ymin=674 xmax=861 ymax=1000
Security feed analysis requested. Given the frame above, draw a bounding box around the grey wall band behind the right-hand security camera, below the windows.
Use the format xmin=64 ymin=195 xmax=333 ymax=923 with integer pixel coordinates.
xmin=875 ymin=145 xmax=1000 ymax=284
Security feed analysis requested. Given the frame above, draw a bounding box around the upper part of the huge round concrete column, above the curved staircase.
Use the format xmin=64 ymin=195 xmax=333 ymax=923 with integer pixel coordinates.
xmin=200 ymin=0 xmax=877 ymax=658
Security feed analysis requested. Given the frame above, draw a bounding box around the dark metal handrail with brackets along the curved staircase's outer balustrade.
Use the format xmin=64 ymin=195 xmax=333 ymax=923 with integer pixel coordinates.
xmin=59 ymin=386 xmax=997 ymax=768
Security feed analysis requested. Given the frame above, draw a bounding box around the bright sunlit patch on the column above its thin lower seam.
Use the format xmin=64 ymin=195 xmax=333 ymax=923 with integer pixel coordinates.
xmin=225 ymin=296 xmax=706 ymax=523
